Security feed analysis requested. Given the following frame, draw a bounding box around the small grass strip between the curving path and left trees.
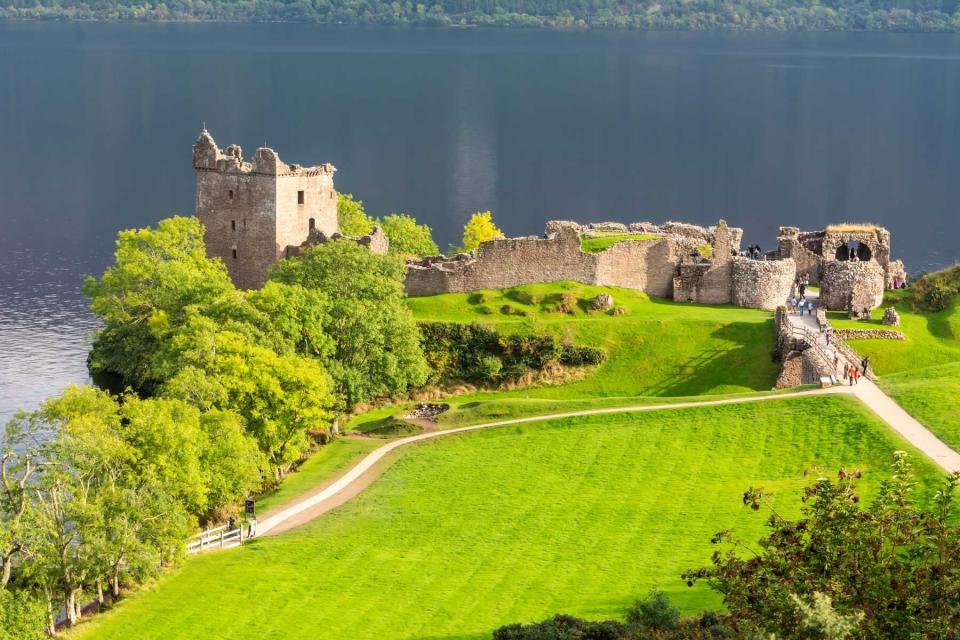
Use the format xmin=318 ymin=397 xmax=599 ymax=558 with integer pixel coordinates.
xmin=257 ymin=438 xmax=383 ymax=515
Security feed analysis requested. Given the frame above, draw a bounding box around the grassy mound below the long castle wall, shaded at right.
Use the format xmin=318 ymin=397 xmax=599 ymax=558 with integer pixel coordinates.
xmin=407 ymin=282 xmax=779 ymax=399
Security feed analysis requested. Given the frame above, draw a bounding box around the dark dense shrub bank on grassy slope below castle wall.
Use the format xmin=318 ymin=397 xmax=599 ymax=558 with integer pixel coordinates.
xmin=420 ymin=322 xmax=604 ymax=383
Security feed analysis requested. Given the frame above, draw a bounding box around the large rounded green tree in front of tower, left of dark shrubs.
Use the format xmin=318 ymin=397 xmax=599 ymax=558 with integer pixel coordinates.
xmin=271 ymin=241 xmax=427 ymax=407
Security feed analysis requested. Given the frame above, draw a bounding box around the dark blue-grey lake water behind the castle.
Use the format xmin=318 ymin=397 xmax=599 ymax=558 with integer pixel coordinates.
xmin=0 ymin=23 xmax=960 ymax=421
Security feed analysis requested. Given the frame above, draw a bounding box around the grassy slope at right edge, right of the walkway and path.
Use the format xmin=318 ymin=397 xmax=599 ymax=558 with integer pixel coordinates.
xmin=832 ymin=291 xmax=960 ymax=448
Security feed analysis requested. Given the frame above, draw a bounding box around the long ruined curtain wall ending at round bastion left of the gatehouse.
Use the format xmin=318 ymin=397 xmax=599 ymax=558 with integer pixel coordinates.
xmin=405 ymin=220 xmax=808 ymax=309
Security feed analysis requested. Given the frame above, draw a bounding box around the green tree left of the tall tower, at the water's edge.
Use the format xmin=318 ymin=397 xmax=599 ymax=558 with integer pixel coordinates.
xmin=83 ymin=216 xmax=233 ymax=390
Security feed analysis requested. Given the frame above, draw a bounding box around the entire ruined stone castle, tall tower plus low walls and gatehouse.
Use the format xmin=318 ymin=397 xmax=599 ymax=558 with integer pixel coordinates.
xmin=193 ymin=130 xmax=905 ymax=315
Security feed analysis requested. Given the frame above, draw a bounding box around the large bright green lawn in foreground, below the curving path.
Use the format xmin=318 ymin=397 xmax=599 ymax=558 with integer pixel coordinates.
xmin=76 ymin=396 xmax=939 ymax=640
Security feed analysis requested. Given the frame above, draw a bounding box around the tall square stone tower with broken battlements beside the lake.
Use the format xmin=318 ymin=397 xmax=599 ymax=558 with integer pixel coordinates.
xmin=193 ymin=129 xmax=339 ymax=289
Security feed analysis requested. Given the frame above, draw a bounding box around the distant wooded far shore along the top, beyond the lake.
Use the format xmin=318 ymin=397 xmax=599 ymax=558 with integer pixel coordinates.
xmin=0 ymin=0 xmax=960 ymax=31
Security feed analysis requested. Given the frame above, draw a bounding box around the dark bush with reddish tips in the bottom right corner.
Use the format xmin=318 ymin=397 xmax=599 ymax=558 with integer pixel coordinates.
xmin=685 ymin=452 xmax=960 ymax=638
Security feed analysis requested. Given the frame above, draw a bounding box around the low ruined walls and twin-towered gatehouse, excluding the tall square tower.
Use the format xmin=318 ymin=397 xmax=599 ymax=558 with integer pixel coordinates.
xmin=406 ymin=220 xmax=904 ymax=315
